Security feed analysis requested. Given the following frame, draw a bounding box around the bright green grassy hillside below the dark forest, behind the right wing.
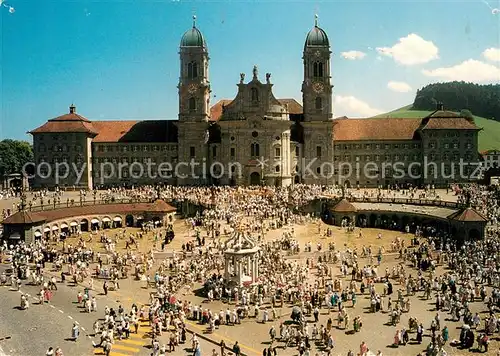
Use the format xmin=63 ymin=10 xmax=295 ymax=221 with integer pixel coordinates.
xmin=375 ymin=105 xmax=500 ymax=152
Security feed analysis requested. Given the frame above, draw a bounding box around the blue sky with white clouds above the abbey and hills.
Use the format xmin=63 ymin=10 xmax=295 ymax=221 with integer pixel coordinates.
xmin=0 ymin=0 xmax=500 ymax=139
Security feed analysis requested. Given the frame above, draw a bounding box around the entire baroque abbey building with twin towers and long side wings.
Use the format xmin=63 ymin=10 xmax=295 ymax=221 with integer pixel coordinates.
xmin=30 ymin=18 xmax=480 ymax=188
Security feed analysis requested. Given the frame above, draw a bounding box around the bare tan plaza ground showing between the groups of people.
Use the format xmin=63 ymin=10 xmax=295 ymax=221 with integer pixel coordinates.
xmin=0 ymin=185 xmax=498 ymax=355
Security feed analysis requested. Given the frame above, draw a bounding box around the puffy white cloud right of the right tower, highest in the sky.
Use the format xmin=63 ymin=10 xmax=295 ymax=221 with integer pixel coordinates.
xmin=377 ymin=33 xmax=439 ymax=66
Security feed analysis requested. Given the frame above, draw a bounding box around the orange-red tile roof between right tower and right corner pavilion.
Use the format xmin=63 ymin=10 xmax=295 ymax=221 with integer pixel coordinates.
xmin=333 ymin=118 xmax=421 ymax=141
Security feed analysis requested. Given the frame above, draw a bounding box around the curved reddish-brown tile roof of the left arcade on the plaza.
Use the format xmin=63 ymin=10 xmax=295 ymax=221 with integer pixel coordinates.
xmin=2 ymin=200 xmax=176 ymax=225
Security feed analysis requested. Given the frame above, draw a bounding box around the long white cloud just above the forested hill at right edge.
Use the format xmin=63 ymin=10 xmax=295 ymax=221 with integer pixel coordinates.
xmin=422 ymin=59 xmax=500 ymax=83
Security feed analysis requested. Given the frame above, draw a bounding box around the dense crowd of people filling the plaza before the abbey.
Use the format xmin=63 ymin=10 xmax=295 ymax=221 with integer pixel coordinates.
xmin=1 ymin=185 xmax=500 ymax=356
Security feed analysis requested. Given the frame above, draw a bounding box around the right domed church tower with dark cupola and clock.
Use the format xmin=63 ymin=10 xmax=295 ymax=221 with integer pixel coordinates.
xmin=302 ymin=15 xmax=333 ymax=121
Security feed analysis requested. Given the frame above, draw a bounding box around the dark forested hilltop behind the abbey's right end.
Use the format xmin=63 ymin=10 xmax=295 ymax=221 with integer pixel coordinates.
xmin=412 ymin=82 xmax=500 ymax=121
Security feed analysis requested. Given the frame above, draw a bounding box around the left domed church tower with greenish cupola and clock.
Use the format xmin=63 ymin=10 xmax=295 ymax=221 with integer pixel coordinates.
xmin=178 ymin=16 xmax=210 ymax=122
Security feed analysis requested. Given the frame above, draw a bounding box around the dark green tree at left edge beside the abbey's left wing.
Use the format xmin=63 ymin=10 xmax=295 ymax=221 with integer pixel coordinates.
xmin=0 ymin=139 xmax=33 ymax=177
